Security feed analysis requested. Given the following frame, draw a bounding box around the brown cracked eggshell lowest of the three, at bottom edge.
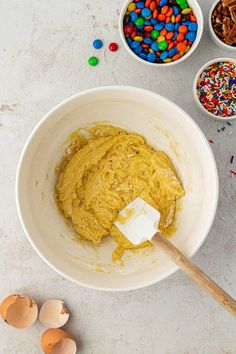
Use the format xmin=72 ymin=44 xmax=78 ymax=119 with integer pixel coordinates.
xmin=41 ymin=328 xmax=77 ymax=354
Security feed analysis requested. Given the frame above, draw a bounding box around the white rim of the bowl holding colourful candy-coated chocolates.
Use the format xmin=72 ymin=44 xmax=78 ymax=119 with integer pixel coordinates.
xmin=119 ymin=0 xmax=204 ymax=68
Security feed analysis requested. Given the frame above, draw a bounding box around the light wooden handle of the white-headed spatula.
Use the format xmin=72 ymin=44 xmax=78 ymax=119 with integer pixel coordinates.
xmin=152 ymin=232 xmax=236 ymax=316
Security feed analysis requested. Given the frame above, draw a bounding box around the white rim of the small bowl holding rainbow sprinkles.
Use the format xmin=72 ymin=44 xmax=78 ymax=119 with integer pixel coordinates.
xmin=193 ymin=57 xmax=236 ymax=122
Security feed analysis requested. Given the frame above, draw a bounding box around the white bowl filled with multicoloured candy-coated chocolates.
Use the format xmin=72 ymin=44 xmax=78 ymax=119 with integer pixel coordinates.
xmin=120 ymin=0 xmax=203 ymax=67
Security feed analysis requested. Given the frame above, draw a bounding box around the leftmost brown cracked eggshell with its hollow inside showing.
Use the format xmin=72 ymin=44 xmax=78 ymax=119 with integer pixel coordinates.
xmin=0 ymin=294 xmax=38 ymax=329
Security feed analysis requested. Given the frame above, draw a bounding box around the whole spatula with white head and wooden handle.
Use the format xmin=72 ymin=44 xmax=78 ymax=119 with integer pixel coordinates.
xmin=115 ymin=197 xmax=236 ymax=315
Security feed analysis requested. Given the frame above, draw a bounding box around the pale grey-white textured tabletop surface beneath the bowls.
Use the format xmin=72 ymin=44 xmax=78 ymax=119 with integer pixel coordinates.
xmin=0 ymin=0 xmax=236 ymax=354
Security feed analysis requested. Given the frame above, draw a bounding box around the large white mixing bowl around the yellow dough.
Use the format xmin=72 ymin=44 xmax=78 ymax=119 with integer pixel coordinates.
xmin=16 ymin=87 xmax=218 ymax=291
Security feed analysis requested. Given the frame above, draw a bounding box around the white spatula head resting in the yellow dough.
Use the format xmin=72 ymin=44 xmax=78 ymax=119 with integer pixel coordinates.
xmin=115 ymin=197 xmax=160 ymax=245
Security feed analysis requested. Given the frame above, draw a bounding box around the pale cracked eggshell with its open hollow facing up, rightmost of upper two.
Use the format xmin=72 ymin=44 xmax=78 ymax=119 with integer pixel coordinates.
xmin=39 ymin=299 xmax=69 ymax=328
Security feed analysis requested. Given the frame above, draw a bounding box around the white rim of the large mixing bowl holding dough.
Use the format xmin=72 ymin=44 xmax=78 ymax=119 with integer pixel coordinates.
xmin=15 ymin=86 xmax=219 ymax=292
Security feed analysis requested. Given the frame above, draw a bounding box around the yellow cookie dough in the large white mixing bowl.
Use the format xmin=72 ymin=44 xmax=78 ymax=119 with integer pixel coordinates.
xmin=56 ymin=125 xmax=184 ymax=260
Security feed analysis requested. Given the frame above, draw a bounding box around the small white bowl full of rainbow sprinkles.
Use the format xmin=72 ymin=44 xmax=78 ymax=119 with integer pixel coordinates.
xmin=193 ymin=58 xmax=236 ymax=120
